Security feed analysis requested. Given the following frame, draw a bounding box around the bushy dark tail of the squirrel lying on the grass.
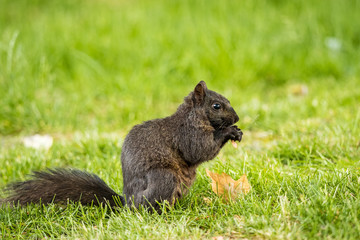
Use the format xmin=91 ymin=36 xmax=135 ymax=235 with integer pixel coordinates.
xmin=0 ymin=169 xmax=125 ymax=207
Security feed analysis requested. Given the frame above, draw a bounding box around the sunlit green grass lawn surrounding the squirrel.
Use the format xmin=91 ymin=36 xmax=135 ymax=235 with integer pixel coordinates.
xmin=0 ymin=0 xmax=360 ymax=239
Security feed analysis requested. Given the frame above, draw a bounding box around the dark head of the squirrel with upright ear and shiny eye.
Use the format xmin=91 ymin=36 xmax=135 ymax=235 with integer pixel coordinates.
xmin=192 ymin=81 xmax=239 ymax=129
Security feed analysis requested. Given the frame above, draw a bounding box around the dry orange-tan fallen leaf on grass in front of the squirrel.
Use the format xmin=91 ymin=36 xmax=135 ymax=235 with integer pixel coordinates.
xmin=206 ymin=169 xmax=251 ymax=201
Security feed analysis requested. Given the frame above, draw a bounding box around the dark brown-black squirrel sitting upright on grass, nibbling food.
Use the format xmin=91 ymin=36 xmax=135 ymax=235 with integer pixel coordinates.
xmin=0 ymin=81 xmax=243 ymax=212
